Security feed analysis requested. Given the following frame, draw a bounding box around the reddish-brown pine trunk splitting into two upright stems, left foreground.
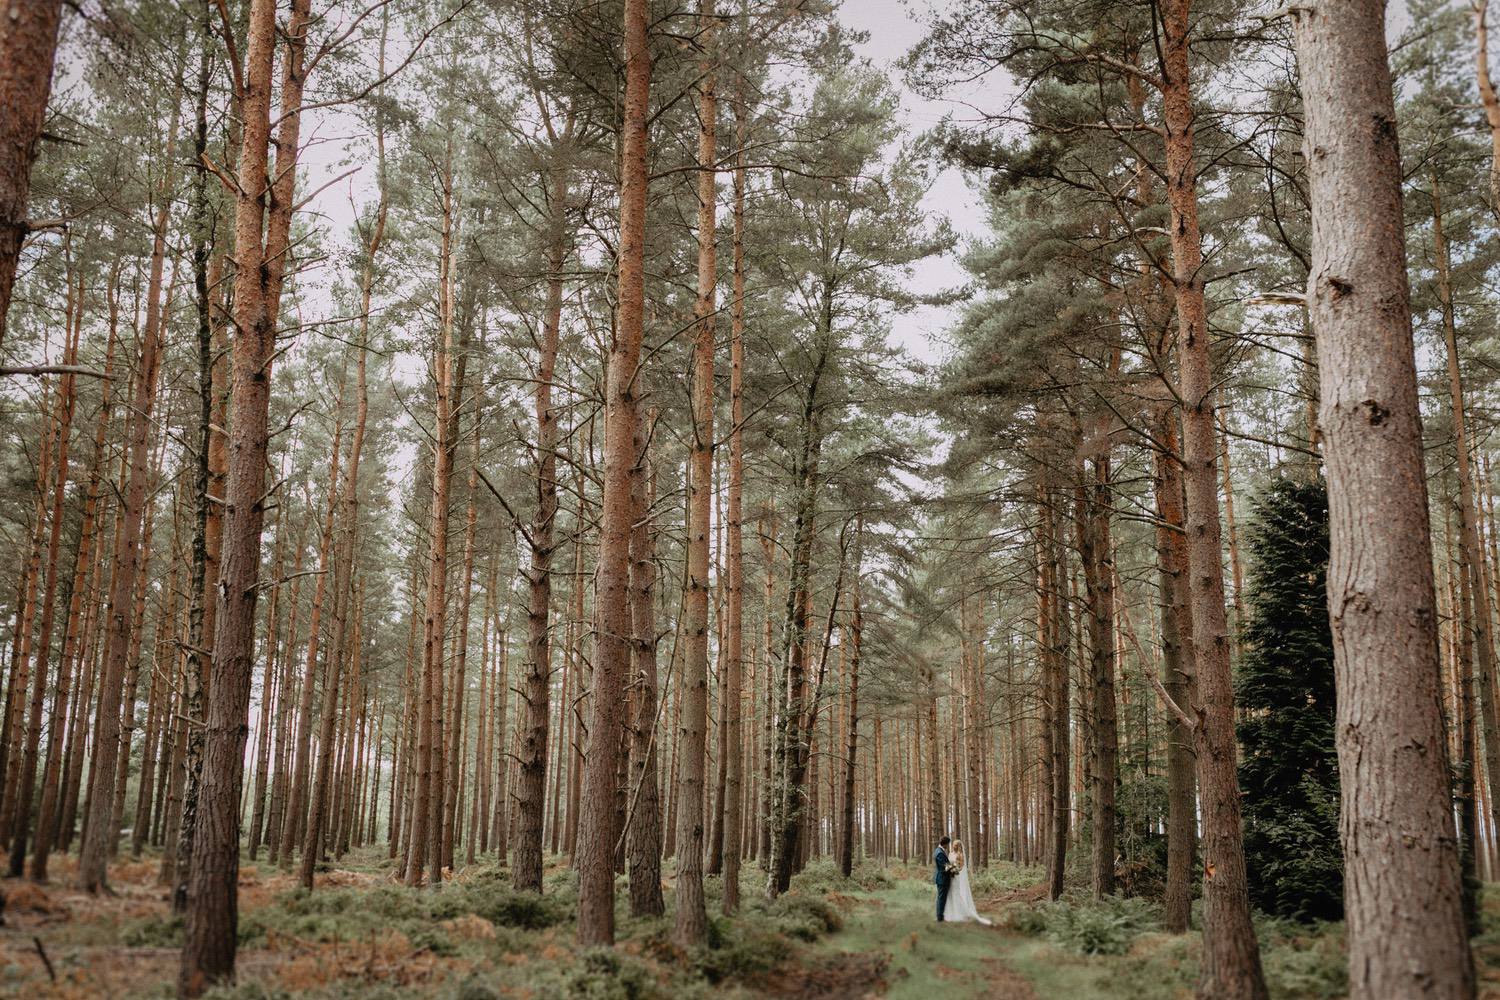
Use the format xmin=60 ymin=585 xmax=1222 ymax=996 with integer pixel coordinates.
xmin=177 ymin=0 xmax=311 ymax=997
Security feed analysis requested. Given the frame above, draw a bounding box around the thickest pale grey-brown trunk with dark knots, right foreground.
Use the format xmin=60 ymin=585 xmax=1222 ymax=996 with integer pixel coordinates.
xmin=1293 ymin=0 xmax=1475 ymax=1000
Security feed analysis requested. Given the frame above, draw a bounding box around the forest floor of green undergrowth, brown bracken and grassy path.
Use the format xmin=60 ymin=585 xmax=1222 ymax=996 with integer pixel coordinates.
xmin=0 ymin=853 xmax=1500 ymax=1000
